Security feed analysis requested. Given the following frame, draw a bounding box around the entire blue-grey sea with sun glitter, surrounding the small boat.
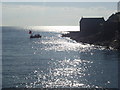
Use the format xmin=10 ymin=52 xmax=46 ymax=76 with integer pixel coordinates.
xmin=0 ymin=26 xmax=120 ymax=88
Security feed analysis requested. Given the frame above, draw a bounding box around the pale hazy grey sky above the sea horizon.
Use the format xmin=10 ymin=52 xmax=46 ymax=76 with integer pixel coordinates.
xmin=2 ymin=2 xmax=117 ymax=26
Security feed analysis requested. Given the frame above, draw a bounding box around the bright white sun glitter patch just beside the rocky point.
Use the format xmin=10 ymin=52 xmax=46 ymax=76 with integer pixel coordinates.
xmin=34 ymin=34 xmax=105 ymax=52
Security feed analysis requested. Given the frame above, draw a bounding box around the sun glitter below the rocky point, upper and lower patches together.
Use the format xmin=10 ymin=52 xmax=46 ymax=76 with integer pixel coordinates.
xmin=23 ymin=35 xmax=95 ymax=88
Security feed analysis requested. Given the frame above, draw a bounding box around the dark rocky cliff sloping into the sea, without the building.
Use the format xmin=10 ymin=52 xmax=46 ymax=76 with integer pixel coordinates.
xmin=63 ymin=12 xmax=120 ymax=50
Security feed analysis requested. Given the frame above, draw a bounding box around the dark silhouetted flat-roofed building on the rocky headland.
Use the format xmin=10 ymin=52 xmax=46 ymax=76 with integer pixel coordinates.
xmin=80 ymin=17 xmax=105 ymax=35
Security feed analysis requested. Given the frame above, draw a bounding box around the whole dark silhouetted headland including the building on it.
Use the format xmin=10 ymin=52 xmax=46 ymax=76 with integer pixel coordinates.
xmin=62 ymin=12 xmax=120 ymax=50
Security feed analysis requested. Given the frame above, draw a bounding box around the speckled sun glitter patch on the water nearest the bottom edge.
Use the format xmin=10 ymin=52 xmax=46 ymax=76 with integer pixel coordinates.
xmin=26 ymin=59 xmax=93 ymax=88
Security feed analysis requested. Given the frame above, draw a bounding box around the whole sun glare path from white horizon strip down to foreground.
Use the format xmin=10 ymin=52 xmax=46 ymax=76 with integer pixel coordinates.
xmin=18 ymin=26 xmax=109 ymax=88
